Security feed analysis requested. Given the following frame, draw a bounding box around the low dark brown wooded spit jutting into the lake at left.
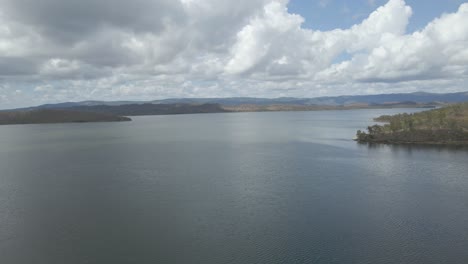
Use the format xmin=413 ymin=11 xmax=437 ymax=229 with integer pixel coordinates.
xmin=0 ymin=109 xmax=131 ymax=125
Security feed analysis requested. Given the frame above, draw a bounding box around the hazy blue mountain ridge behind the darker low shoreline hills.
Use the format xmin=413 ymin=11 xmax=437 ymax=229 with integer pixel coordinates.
xmin=10 ymin=92 xmax=468 ymax=110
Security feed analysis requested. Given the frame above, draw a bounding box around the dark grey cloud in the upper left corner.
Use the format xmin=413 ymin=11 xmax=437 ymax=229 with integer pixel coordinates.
xmin=0 ymin=0 xmax=184 ymax=43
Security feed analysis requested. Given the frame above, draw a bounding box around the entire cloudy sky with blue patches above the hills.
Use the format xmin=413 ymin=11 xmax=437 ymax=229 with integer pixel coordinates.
xmin=0 ymin=0 xmax=468 ymax=109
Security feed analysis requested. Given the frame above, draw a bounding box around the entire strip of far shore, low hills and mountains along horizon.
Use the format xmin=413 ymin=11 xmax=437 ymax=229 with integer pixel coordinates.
xmin=0 ymin=92 xmax=468 ymax=124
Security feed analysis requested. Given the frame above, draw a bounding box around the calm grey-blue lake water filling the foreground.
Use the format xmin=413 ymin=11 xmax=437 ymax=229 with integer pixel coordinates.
xmin=0 ymin=109 xmax=468 ymax=264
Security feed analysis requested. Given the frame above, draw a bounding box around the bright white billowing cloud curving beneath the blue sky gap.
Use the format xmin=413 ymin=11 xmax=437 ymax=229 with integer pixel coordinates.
xmin=225 ymin=0 xmax=411 ymax=79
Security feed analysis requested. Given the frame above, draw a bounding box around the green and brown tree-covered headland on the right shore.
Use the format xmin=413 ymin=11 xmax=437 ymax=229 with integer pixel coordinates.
xmin=356 ymin=103 xmax=468 ymax=146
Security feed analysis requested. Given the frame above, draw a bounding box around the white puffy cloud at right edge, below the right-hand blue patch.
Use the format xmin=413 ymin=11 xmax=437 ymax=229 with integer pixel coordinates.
xmin=325 ymin=1 xmax=468 ymax=83
